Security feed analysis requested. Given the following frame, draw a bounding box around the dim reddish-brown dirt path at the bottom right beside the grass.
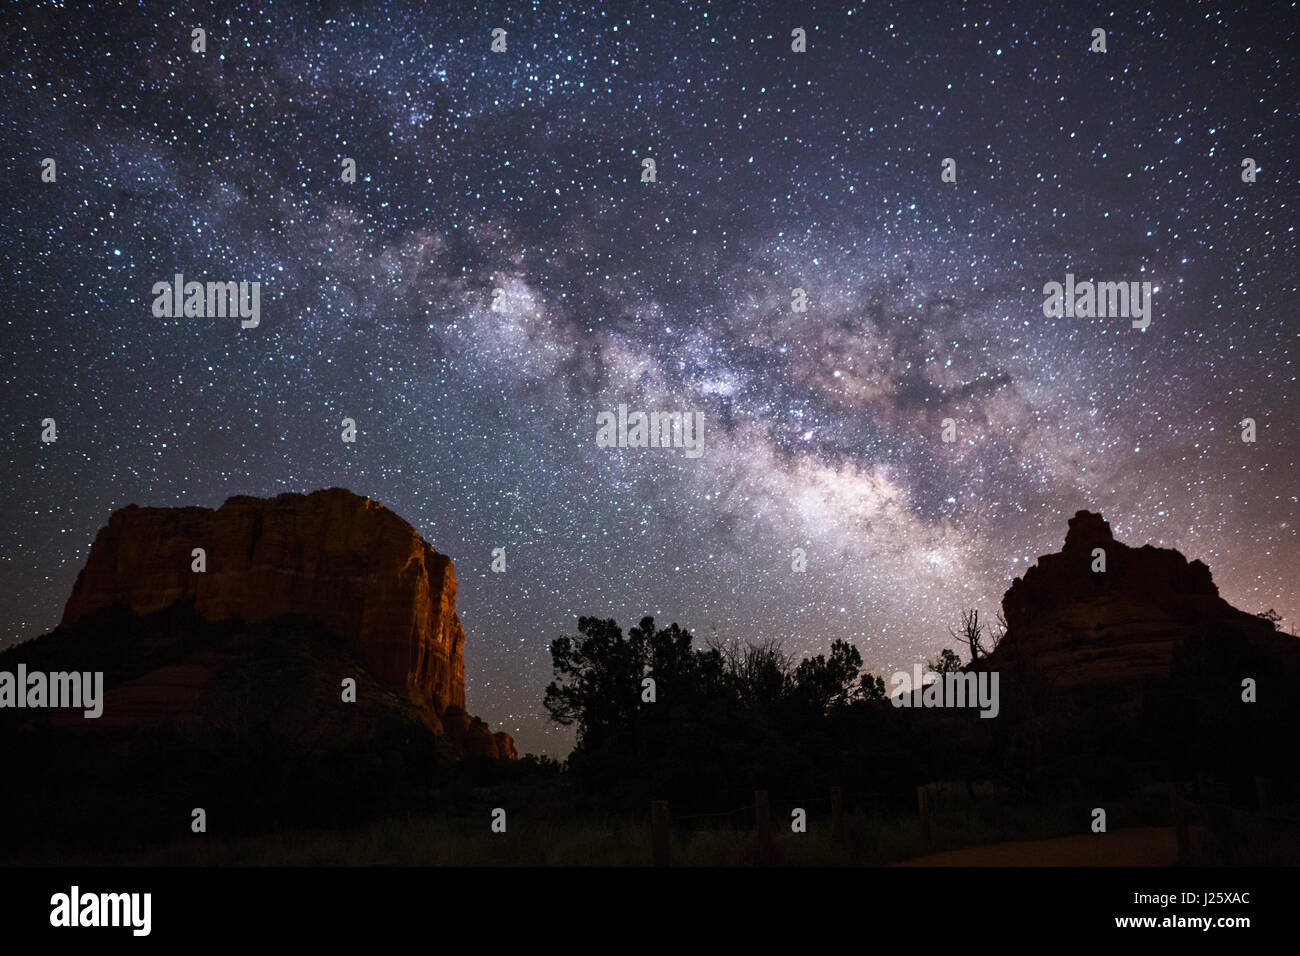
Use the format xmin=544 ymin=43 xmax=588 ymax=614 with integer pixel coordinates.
xmin=898 ymin=826 xmax=1178 ymax=866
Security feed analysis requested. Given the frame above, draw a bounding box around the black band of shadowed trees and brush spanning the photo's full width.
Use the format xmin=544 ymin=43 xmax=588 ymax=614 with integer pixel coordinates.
xmin=0 ymin=605 xmax=1300 ymax=862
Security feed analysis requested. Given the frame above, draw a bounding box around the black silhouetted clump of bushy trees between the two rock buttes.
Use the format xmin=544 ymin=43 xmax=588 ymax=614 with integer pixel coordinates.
xmin=545 ymin=618 xmax=914 ymax=812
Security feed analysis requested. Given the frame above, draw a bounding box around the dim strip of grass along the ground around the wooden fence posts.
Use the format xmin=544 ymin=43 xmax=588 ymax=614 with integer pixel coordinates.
xmin=7 ymin=783 xmax=1201 ymax=868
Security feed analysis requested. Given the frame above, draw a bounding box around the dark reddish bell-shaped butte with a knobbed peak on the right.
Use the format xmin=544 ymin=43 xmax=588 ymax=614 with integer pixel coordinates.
xmin=984 ymin=511 xmax=1300 ymax=688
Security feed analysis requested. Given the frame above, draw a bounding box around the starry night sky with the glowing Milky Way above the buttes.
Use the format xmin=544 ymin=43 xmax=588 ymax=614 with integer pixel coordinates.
xmin=0 ymin=0 xmax=1300 ymax=754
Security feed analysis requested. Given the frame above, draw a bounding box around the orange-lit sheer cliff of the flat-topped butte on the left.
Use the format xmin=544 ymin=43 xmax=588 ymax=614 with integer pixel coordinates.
xmin=62 ymin=488 xmax=515 ymax=756
